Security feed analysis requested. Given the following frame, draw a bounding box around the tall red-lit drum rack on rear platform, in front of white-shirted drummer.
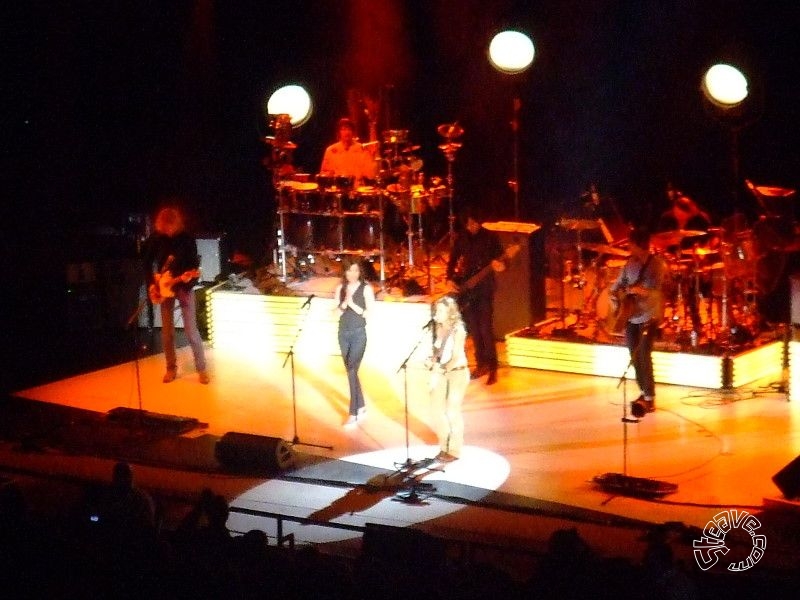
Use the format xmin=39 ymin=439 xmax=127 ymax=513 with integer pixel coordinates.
xmin=265 ymin=120 xmax=464 ymax=288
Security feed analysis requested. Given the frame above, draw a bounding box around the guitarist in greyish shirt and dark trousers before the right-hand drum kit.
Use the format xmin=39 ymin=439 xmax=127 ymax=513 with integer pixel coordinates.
xmin=609 ymin=228 xmax=667 ymax=417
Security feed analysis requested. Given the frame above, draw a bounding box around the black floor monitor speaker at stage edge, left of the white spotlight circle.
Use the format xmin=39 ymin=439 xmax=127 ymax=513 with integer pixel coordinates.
xmin=214 ymin=431 xmax=294 ymax=473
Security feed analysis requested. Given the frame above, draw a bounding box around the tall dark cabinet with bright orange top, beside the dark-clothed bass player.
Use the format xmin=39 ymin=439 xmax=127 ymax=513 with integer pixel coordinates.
xmin=483 ymin=221 xmax=547 ymax=340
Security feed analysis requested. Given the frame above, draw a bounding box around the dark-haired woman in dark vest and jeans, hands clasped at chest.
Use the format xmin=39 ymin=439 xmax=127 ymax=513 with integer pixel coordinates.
xmin=333 ymin=259 xmax=375 ymax=427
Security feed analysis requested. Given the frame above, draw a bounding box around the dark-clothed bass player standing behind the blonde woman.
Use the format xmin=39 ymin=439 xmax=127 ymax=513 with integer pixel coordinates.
xmin=447 ymin=208 xmax=505 ymax=385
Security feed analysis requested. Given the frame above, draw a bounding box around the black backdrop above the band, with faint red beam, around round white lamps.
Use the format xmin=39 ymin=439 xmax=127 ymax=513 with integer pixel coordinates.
xmin=0 ymin=0 xmax=800 ymax=384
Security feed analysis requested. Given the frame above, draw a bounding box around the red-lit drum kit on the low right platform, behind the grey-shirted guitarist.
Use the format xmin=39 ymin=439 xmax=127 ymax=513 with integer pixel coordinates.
xmin=557 ymin=219 xmax=761 ymax=348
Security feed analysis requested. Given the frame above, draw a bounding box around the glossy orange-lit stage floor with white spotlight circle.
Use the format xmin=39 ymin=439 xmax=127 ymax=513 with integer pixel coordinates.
xmin=9 ymin=344 xmax=800 ymax=564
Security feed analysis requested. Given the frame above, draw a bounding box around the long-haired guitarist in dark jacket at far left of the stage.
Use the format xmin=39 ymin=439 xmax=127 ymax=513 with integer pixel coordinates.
xmin=142 ymin=207 xmax=209 ymax=384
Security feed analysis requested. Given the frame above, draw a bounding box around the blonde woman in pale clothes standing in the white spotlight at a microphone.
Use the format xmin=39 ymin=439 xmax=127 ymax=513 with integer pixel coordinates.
xmin=428 ymin=296 xmax=469 ymax=462
